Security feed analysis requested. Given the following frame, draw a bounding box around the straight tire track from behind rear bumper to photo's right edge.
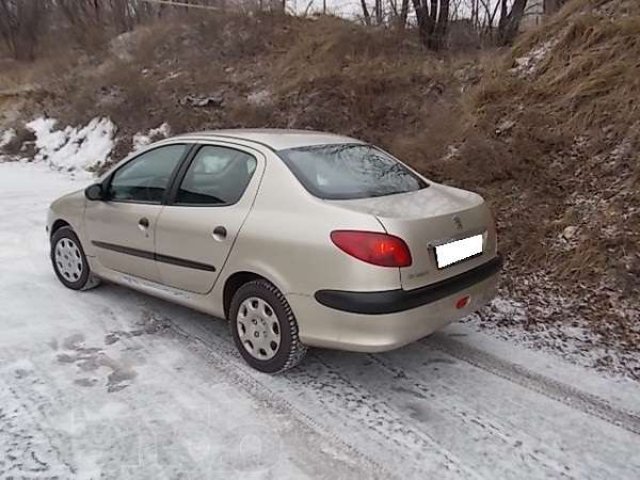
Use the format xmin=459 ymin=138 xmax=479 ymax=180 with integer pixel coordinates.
xmin=419 ymin=333 xmax=640 ymax=435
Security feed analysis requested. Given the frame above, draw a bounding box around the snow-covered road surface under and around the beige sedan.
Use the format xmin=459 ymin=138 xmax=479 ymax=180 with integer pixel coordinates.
xmin=0 ymin=164 xmax=640 ymax=480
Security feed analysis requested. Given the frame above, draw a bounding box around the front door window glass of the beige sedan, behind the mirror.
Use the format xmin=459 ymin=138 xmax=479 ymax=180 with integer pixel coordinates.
xmin=109 ymin=145 xmax=187 ymax=203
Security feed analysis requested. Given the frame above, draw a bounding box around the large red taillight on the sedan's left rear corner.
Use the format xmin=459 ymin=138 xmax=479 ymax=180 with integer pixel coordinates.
xmin=331 ymin=230 xmax=411 ymax=267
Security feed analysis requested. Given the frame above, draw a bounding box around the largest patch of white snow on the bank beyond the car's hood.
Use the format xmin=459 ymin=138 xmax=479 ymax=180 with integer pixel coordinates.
xmin=26 ymin=117 xmax=116 ymax=172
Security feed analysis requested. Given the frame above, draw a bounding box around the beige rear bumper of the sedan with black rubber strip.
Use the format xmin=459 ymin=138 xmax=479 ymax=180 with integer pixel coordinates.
xmin=287 ymin=258 xmax=502 ymax=352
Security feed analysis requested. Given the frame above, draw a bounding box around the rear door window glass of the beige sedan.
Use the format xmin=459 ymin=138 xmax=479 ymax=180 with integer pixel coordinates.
xmin=175 ymin=145 xmax=257 ymax=206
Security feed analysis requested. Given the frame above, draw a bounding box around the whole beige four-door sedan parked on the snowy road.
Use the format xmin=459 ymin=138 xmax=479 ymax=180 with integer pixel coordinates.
xmin=48 ymin=130 xmax=501 ymax=373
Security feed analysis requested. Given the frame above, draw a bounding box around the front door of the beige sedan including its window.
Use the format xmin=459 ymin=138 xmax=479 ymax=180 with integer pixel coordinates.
xmin=85 ymin=144 xmax=189 ymax=281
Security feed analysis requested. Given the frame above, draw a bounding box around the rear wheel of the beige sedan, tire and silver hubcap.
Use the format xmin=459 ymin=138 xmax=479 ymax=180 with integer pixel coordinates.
xmin=229 ymin=280 xmax=307 ymax=373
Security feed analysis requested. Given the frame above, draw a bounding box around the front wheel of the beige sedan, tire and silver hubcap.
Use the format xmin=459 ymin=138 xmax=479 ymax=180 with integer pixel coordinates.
xmin=50 ymin=227 xmax=100 ymax=290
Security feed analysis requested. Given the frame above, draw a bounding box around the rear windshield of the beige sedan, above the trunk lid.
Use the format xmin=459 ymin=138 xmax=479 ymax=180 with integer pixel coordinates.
xmin=278 ymin=144 xmax=427 ymax=200
